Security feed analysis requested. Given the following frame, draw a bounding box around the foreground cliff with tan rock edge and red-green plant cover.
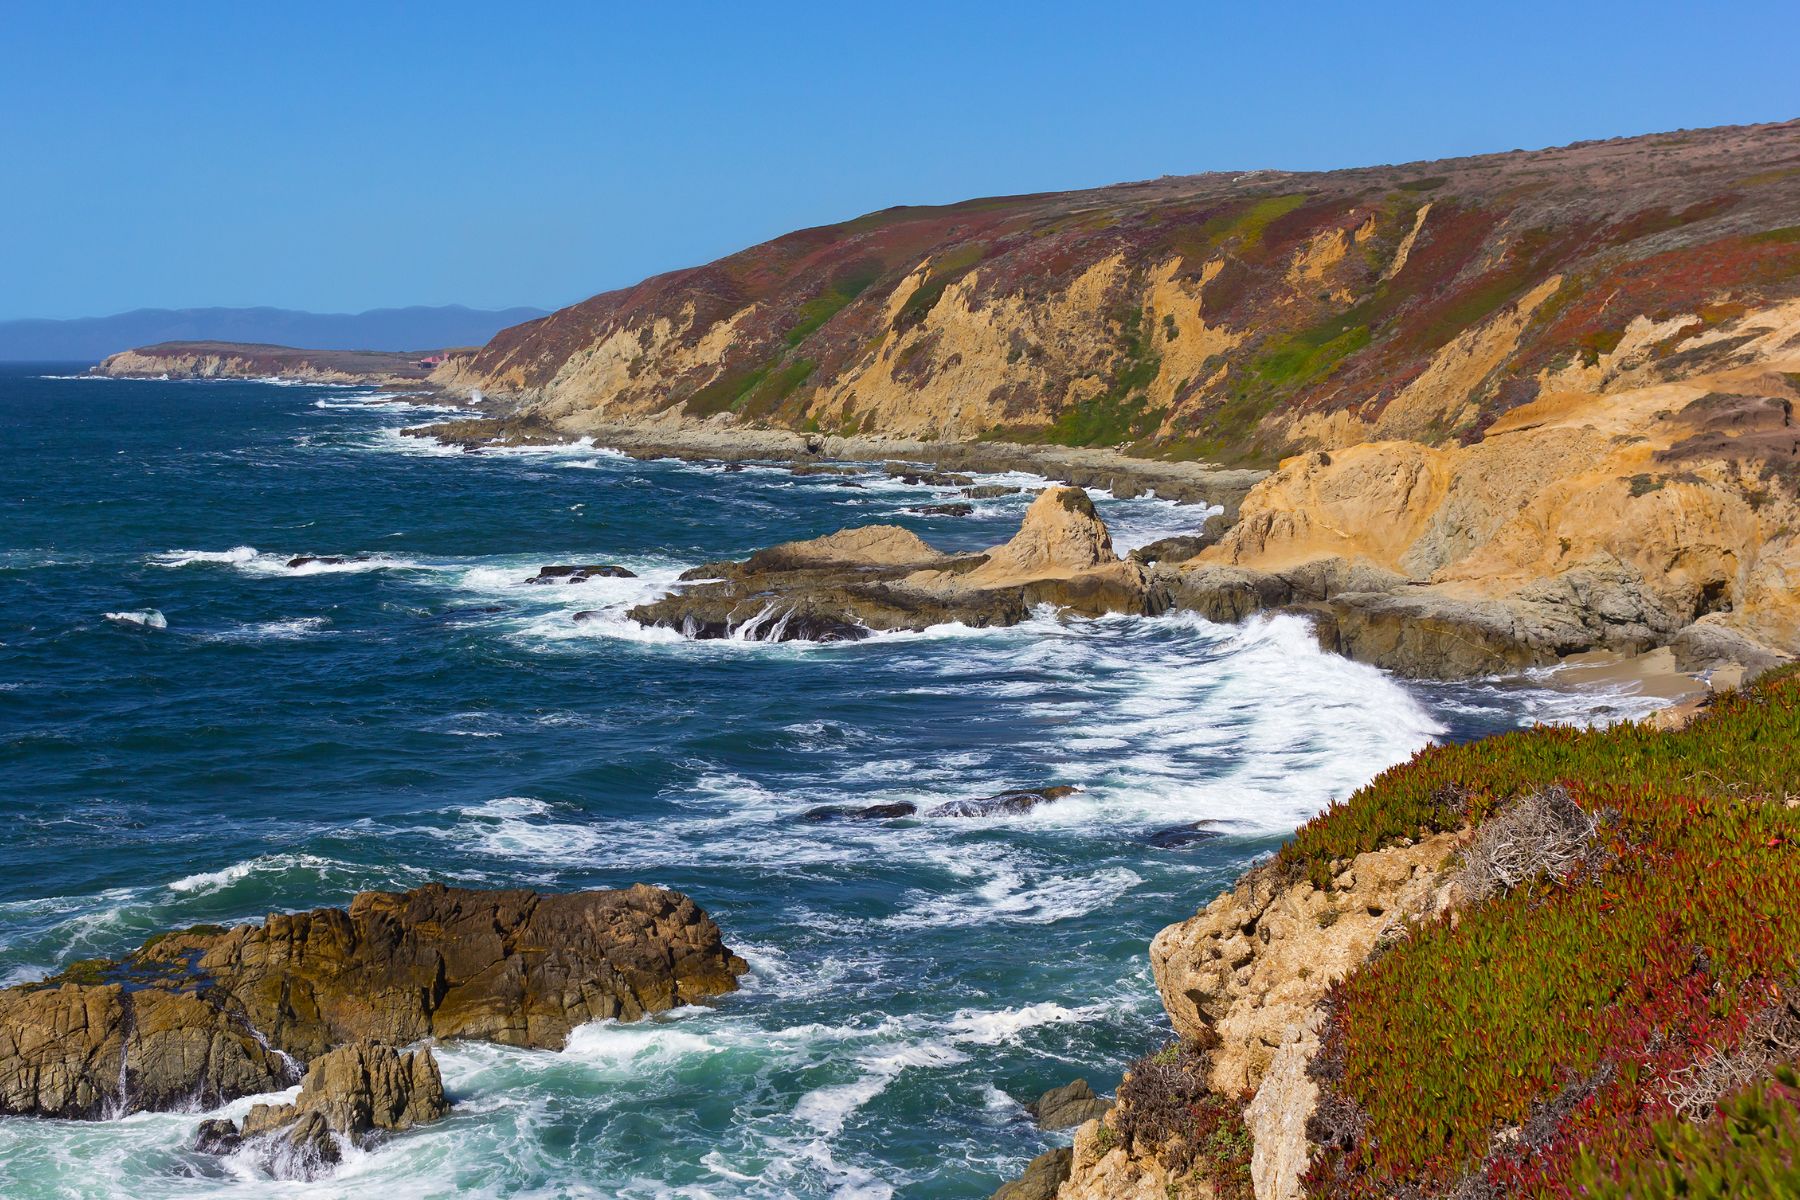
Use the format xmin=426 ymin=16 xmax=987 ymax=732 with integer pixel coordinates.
xmin=1035 ymin=671 xmax=1800 ymax=1200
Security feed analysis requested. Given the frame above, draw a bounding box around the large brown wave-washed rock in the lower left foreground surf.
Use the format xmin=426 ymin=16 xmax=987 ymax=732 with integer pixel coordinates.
xmin=0 ymin=883 xmax=747 ymax=1117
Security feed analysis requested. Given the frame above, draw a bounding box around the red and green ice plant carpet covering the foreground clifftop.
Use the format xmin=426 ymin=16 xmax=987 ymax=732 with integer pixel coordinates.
xmin=1280 ymin=669 xmax=1800 ymax=1196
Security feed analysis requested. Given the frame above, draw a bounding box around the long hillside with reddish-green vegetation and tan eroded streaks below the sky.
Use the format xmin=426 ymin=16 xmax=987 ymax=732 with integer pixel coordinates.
xmin=442 ymin=122 xmax=1800 ymax=464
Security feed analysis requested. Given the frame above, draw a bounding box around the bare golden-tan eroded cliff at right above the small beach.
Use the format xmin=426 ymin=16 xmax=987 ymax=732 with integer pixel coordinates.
xmin=1193 ymin=302 xmax=1800 ymax=675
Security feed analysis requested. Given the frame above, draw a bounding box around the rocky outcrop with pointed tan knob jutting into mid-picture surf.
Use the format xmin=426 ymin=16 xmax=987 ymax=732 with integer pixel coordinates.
xmin=630 ymin=488 xmax=1154 ymax=640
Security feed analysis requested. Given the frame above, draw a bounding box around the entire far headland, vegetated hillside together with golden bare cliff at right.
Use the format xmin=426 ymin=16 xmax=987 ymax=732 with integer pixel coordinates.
xmin=412 ymin=122 xmax=1800 ymax=676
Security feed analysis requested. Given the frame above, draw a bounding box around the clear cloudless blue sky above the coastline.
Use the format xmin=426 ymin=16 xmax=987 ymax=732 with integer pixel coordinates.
xmin=0 ymin=0 xmax=1800 ymax=318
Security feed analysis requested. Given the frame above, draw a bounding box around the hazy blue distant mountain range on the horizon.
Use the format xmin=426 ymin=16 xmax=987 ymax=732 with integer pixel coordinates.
xmin=0 ymin=304 xmax=544 ymax=362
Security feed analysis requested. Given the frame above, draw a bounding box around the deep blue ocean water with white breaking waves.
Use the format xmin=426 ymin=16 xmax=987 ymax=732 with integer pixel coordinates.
xmin=0 ymin=367 xmax=1643 ymax=1200
